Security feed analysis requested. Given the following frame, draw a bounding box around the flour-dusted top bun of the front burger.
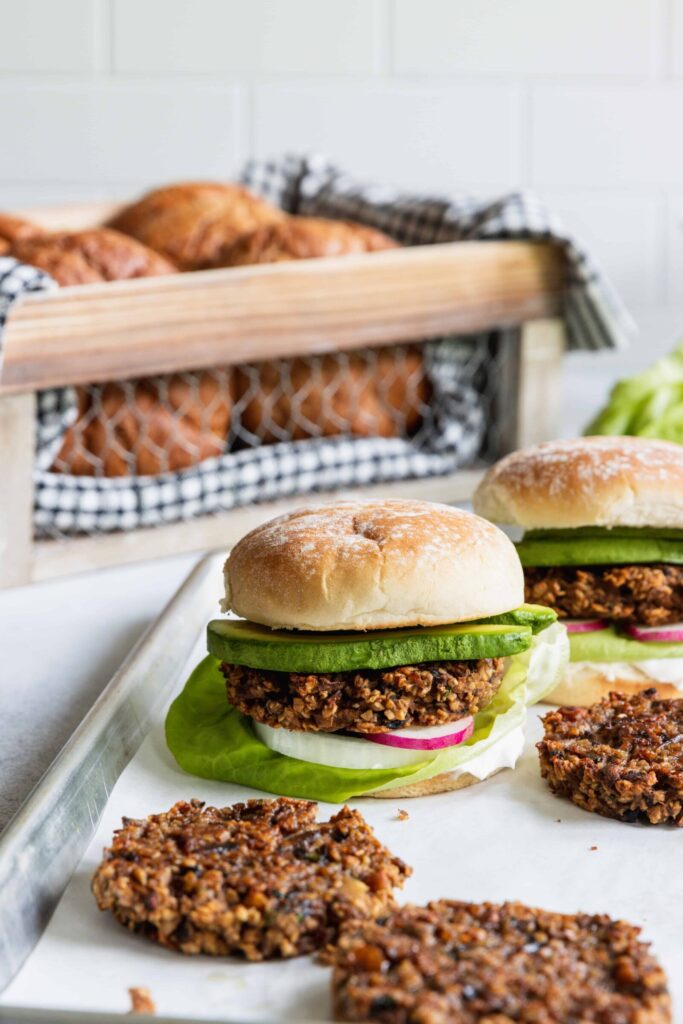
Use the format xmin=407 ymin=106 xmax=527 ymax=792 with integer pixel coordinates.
xmin=223 ymin=501 xmax=524 ymax=630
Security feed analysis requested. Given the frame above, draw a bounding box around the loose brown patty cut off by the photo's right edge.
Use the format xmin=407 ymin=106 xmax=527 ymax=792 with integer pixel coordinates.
xmin=537 ymin=688 xmax=683 ymax=825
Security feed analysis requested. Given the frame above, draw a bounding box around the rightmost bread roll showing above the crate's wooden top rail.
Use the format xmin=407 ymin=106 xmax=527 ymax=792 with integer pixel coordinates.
xmin=216 ymin=217 xmax=398 ymax=266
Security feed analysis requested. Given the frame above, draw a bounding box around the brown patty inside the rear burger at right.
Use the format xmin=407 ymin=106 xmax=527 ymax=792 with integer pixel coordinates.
xmin=524 ymin=565 xmax=683 ymax=626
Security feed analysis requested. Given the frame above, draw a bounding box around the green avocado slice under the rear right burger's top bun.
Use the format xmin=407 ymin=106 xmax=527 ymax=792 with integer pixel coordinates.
xmin=516 ymin=526 xmax=683 ymax=566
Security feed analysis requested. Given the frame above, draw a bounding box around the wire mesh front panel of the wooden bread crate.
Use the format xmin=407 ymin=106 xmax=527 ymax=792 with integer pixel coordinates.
xmin=36 ymin=331 xmax=519 ymax=538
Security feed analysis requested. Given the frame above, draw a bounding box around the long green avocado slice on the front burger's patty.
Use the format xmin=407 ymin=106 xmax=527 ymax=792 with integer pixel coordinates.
xmin=207 ymin=618 xmax=533 ymax=674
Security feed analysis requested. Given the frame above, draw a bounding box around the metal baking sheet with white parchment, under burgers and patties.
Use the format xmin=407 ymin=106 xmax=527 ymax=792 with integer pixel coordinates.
xmin=0 ymin=556 xmax=683 ymax=1024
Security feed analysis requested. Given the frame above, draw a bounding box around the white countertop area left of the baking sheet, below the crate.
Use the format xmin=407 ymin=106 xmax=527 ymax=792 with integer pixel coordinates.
xmin=0 ymin=555 xmax=199 ymax=829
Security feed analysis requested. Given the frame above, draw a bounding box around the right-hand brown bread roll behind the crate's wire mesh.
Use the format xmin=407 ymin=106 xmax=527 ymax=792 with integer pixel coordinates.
xmin=236 ymin=346 xmax=430 ymax=444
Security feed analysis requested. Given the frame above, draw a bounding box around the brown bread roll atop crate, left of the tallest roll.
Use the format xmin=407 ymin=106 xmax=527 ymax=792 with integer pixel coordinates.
xmin=10 ymin=227 xmax=177 ymax=286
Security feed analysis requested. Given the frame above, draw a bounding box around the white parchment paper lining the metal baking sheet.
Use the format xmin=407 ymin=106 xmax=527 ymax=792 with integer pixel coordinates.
xmin=0 ymin=640 xmax=683 ymax=1022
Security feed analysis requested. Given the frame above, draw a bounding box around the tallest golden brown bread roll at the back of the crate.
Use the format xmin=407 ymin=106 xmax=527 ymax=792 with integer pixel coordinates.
xmin=110 ymin=181 xmax=286 ymax=270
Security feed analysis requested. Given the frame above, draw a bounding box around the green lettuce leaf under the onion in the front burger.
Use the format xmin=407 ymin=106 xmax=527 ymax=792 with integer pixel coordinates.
xmin=166 ymin=651 xmax=530 ymax=803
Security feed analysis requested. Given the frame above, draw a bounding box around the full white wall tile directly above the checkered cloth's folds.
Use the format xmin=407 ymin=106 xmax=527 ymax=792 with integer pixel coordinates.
xmin=254 ymin=83 xmax=520 ymax=191
